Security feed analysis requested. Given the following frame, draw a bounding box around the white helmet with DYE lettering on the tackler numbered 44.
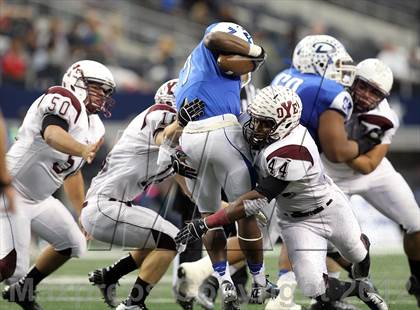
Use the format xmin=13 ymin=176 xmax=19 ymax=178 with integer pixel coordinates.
xmin=244 ymin=86 xmax=302 ymax=149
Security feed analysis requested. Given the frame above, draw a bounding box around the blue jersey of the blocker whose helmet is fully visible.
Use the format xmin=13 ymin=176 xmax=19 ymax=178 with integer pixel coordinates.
xmin=271 ymin=68 xmax=353 ymax=151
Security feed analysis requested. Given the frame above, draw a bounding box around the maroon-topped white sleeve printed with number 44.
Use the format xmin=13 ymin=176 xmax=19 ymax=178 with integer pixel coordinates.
xmin=265 ymin=145 xmax=314 ymax=181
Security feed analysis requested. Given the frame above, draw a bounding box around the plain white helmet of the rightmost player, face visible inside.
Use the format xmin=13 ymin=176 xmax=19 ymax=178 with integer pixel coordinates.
xmin=350 ymin=58 xmax=394 ymax=113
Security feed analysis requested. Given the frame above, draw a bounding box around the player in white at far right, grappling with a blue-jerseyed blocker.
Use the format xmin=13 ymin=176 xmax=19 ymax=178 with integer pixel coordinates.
xmin=322 ymin=58 xmax=420 ymax=307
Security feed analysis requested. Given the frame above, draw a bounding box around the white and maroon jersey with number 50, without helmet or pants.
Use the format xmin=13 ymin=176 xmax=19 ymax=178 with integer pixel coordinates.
xmin=7 ymin=86 xmax=105 ymax=202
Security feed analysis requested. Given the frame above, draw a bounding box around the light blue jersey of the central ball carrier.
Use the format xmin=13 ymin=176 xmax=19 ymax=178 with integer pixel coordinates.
xmin=175 ymin=24 xmax=241 ymax=119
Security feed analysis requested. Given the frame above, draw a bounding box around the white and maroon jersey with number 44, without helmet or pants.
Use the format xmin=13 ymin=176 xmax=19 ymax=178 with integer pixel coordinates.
xmin=255 ymin=125 xmax=338 ymax=212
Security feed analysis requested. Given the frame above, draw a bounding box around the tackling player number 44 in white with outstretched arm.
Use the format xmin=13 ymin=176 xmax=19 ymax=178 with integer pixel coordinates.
xmin=175 ymin=86 xmax=388 ymax=309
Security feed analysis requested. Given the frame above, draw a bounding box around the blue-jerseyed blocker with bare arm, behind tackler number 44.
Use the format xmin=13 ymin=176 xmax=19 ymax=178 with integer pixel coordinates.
xmin=267 ymin=35 xmax=384 ymax=309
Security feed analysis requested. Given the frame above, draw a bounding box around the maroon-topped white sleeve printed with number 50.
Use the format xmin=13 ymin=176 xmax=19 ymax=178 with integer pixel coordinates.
xmin=38 ymin=86 xmax=82 ymax=130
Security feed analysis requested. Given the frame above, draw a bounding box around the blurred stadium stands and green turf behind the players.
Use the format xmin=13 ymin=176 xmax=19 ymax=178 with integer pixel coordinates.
xmin=0 ymin=0 xmax=420 ymax=309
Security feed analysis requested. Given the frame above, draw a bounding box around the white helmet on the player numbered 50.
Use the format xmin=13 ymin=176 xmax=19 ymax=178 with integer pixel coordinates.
xmin=62 ymin=60 xmax=116 ymax=117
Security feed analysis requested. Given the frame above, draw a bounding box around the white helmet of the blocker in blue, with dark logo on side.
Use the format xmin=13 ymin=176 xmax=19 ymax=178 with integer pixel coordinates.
xmin=293 ymin=35 xmax=356 ymax=86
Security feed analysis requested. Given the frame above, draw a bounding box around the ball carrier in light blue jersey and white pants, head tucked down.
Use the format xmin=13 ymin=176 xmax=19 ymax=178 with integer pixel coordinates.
xmin=175 ymin=22 xmax=278 ymax=309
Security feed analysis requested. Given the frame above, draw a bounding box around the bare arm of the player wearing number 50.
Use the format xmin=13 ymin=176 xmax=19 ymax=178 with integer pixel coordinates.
xmin=44 ymin=125 xmax=86 ymax=157
